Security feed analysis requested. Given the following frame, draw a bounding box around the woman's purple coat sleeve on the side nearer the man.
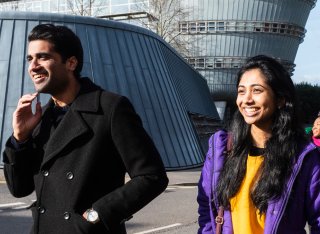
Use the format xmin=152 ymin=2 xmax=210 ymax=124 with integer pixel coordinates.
xmin=197 ymin=136 xmax=213 ymax=234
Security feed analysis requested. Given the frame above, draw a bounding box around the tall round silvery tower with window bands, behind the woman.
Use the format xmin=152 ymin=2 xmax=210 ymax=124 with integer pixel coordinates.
xmin=179 ymin=0 xmax=316 ymax=100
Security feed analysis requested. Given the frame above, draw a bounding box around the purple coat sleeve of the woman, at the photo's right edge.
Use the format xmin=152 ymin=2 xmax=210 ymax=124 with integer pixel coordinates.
xmin=306 ymin=151 xmax=320 ymax=234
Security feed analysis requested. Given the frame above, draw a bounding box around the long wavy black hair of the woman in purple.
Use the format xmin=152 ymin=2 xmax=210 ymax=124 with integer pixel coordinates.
xmin=217 ymin=55 xmax=304 ymax=214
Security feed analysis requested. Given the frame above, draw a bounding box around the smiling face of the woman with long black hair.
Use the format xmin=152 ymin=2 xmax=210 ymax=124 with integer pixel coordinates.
xmin=236 ymin=68 xmax=277 ymax=131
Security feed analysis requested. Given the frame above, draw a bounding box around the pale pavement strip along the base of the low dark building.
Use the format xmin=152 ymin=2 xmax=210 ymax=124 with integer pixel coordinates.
xmin=0 ymin=167 xmax=201 ymax=186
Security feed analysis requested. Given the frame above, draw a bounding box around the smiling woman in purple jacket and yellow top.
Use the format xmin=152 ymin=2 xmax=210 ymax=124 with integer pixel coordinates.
xmin=197 ymin=55 xmax=320 ymax=234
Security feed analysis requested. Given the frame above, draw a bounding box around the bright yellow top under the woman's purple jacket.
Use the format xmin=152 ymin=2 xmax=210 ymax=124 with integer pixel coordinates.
xmin=230 ymin=155 xmax=265 ymax=234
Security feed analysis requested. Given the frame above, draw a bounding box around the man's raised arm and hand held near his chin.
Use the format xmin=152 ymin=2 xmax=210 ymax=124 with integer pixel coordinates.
xmin=3 ymin=93 xmax=42 ymax=197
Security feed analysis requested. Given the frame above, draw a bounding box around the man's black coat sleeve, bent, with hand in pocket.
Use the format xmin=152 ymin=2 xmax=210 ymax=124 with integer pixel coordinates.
xmin=93 ymin=97 xmax=168 ymax=228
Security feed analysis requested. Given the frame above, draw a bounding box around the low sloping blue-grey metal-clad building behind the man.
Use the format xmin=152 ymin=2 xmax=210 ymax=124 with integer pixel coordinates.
xmin=0 ymin=12 xmax=219 ymax=169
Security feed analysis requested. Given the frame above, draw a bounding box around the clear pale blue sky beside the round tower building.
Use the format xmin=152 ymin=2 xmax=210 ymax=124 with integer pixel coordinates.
xmin=292 ymin=0 xmax=320 ymax=86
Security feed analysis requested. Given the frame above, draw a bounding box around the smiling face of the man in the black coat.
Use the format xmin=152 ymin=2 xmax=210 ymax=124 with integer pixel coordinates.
xmin=27 ymin=40 xmax=73 ymax=96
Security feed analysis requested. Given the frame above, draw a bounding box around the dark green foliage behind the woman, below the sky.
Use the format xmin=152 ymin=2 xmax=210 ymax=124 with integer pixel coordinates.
xmin=295 ymin=82 xmax=320 ymax=125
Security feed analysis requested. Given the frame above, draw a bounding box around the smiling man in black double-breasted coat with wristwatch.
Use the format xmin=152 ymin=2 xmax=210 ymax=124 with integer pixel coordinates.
xmin=3 ymin=24 xmax=168 ymax=234
